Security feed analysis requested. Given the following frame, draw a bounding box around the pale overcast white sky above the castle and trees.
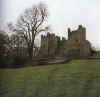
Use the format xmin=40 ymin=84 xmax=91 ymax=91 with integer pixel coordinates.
xmin=0 ymin=0 xmax=100 ymax=48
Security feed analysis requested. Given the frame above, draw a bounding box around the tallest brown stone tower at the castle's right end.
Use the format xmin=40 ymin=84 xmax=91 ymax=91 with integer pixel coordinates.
xmin=67 ymin=25 xmax=91 ymax=58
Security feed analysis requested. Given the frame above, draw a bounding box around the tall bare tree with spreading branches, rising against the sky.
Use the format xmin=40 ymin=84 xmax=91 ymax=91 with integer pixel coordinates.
xmin=9 ymin=3 xmax=48 ymax=59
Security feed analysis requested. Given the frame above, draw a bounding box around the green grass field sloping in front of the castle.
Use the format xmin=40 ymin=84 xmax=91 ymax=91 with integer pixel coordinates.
xmin=0 ymin=60 xmax=100 ymax=97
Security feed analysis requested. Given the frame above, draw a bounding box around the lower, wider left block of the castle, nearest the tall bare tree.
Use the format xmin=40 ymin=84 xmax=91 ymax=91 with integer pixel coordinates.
xmin=40 ymin=33 xmax=60 ymax=57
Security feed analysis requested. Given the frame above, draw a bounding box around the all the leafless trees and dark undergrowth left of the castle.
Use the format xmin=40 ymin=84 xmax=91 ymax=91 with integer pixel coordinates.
xmin=0 ymin=3 xmax=49 ymax=67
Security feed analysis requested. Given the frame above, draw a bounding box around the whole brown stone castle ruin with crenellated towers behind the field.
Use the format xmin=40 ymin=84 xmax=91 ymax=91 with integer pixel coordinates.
xmin=40 ymin=25 xmax=91 ymax=58
